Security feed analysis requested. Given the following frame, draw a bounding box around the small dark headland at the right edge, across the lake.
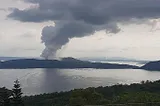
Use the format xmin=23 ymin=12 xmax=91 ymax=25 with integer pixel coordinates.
xmin=141 ymin=61 xmax=160 ymax=71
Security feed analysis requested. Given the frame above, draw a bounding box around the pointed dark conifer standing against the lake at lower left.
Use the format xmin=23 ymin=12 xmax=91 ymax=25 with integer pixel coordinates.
xmin=12 ymin=79 xmax=23 ymax=106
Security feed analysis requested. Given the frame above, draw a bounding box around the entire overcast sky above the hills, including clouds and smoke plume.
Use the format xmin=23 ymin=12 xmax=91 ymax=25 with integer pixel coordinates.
xmin=0 ymin=0 xmax=160 ymax=60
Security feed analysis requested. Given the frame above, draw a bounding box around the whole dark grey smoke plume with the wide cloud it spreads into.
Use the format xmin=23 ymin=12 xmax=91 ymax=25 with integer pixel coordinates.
xmin=8 ymin=0 xmax=160 ymax=58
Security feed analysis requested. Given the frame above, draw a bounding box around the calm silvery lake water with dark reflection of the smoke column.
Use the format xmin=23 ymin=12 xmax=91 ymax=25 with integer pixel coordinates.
xmin=0 ymin=69 xmax=160 ymax=95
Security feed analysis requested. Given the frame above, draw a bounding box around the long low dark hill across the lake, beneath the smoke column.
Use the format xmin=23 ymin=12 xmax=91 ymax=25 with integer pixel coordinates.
xmin=0 ymin=58 xmax=139 ymax=69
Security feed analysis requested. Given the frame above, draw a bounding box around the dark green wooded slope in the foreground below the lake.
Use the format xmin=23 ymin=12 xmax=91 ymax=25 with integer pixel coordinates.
xmin=0 ymin=80 xmax=160 ymax=106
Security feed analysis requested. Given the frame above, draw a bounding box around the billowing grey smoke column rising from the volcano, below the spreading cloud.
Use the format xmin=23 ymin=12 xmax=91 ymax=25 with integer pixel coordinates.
xmin=41 ymin=21 xmax=95 ymax=59
